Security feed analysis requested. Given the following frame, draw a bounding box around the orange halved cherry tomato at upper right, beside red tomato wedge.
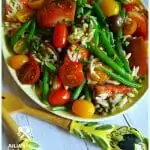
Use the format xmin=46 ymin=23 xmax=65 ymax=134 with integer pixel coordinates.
xmin=123 ymin=18 xmax=137 ymax=35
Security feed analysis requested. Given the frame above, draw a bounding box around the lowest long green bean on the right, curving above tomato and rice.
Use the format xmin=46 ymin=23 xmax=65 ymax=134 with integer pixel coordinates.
xmin=99 ymin=66 xmax=142 ymax=88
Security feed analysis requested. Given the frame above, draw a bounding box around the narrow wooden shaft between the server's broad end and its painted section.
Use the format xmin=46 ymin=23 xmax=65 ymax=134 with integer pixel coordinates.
xmin=24 ymin=106 xmax=71 ymax=130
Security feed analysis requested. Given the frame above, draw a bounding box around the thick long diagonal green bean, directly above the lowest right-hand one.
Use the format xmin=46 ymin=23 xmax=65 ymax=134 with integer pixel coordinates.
xmin=87 ymin=43 xmax=132 ymax=80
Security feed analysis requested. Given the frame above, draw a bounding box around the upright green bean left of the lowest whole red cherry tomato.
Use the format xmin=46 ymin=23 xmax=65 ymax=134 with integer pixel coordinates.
xmin=42 ymin=65 xmax=49 ymax=103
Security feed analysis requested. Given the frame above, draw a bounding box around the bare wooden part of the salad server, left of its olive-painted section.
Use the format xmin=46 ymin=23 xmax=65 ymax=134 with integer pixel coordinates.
xmin=2 ymin=93 xmax=71 ymax=130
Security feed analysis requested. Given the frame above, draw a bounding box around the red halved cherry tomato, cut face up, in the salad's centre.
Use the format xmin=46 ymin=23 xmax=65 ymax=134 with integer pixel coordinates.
xmin=59 ymin=62 xmax=84 ymax=87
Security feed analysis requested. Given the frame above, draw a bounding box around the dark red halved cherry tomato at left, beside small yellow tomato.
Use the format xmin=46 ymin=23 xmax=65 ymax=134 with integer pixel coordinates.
xmin=17 ymin=58 xmax=40 ymax=84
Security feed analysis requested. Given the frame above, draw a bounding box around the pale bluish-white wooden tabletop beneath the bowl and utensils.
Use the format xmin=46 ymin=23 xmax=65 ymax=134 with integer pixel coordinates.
xmin=2 ymin=59 xmax=150 ymax=150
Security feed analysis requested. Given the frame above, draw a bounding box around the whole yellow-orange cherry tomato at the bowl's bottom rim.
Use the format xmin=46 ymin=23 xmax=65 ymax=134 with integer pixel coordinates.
xmin=72 ymin=99 xmax=95 ymax=118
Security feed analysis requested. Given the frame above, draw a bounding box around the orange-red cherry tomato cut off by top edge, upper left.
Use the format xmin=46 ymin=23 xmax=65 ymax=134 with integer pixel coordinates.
xmin=27 ymin=0 xmax=44 ymax=9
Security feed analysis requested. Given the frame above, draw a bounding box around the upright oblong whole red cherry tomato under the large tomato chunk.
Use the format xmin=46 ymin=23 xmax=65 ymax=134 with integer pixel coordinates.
xmin=53 ymin=23 xmax=68 ymax=48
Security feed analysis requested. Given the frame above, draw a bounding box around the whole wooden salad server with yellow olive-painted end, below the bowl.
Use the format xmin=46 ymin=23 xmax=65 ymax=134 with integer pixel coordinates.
xmin=2 ymin=93 xmax=148 ymax=150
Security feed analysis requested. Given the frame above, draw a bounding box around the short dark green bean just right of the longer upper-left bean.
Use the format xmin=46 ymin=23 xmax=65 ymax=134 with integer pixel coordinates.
xmin=27 ymin=20 xmax=36 ymax=42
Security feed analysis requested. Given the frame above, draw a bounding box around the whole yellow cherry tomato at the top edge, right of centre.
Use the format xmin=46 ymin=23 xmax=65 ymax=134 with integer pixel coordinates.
xmin=100 ymin=0 xmax=120 ymax=17
